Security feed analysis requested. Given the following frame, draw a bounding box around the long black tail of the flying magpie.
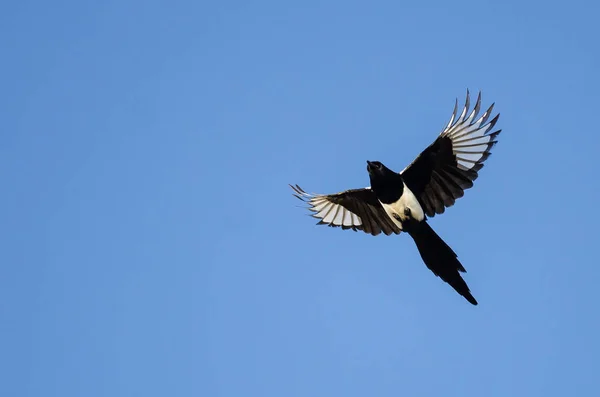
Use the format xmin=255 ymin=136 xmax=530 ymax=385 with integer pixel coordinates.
xmin=403 ymin=221 xmax=477 ymax=305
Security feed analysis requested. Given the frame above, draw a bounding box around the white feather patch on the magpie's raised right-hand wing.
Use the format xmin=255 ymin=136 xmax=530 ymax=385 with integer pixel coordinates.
xmin=441 ymin=91 xmax=498 ymax=171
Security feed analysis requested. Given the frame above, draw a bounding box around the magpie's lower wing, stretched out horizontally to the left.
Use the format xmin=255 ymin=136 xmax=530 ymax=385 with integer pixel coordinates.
xmin=290 ymin=185 xmax=401 ymax=236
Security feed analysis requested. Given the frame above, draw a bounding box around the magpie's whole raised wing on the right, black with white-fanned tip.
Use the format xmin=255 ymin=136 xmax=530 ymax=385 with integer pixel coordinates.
xmin=401 ymin=90 xmax=501 ymax=217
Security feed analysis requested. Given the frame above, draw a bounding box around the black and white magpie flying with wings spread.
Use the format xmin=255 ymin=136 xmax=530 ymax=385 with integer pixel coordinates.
xmin=290 ymin=90 xmax=501 ymax=305
